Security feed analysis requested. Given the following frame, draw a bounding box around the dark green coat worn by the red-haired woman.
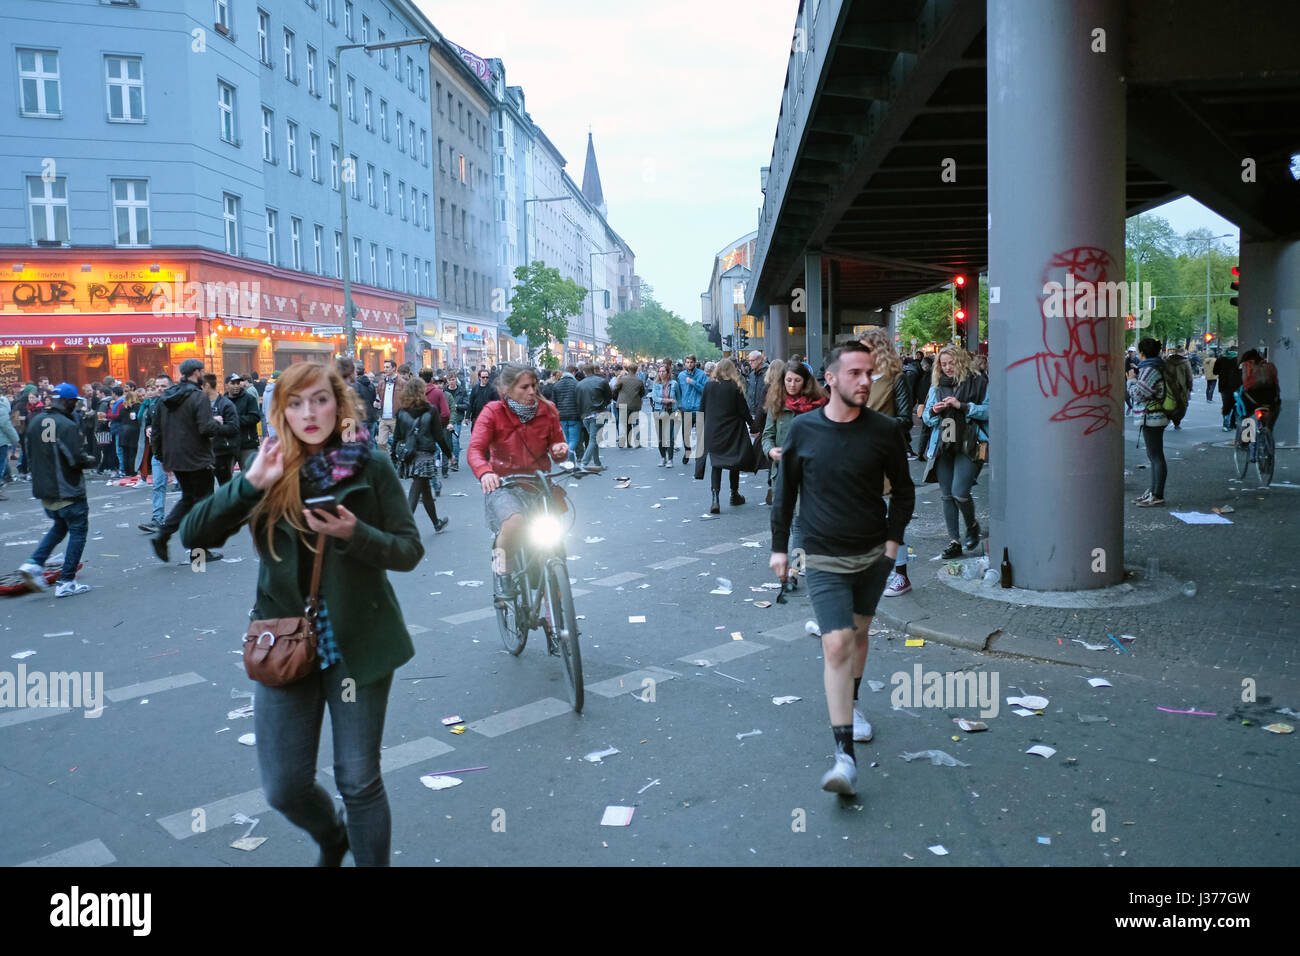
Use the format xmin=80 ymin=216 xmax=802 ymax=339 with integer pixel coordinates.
xmin=181 ymin=455 xmax=424 ymax=685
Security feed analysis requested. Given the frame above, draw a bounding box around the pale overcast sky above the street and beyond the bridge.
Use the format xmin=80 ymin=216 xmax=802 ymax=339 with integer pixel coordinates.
xmin=416 ymin=0 xmax=1236 ymax=321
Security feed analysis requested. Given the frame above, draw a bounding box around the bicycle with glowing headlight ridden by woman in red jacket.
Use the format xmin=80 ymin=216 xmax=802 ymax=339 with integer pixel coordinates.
xmin=493 ymin=462 xmax=597 ymax=713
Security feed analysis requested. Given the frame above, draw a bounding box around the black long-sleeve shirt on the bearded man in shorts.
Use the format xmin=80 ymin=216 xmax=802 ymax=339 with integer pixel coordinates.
xmin=772 ymin=407 xmax=917 ymax=555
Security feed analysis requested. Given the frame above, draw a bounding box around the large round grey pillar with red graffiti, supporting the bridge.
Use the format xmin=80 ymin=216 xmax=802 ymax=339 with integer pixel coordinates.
xmin=975 ymin=0 xmax=1123 ymax=591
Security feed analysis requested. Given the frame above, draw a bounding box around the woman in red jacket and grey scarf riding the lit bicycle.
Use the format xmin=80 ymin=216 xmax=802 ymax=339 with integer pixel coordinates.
xmin=467 ymin=365 xmax=568 ymax=600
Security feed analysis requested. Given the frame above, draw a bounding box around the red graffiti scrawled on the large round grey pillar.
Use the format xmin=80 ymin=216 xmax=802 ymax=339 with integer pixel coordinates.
xmin=1006 ymin=246 xmax=1118 ymax=434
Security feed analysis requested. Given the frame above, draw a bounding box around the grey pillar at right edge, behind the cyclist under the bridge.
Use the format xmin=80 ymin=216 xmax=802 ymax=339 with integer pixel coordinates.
xmin=1236 ymin=235 xmax=1300 ymax=447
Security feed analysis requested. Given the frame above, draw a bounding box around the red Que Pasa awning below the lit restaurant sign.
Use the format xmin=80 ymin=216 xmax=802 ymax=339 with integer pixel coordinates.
xmin=0 ymin=312 xmax=198 ymax=349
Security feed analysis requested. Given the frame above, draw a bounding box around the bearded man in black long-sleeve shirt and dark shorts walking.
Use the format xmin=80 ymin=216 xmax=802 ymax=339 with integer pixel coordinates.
xmin=771 ymin=342 xmax=917 ymax=795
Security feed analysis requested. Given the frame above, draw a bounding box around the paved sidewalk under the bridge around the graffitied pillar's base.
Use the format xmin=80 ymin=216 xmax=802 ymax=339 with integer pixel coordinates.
xmin=878 ymin=395 xmax=1300 ymax=695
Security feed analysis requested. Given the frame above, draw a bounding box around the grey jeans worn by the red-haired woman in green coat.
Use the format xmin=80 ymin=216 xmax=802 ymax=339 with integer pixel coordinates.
xmin=254 ymin=662 xmax=393 ymax=866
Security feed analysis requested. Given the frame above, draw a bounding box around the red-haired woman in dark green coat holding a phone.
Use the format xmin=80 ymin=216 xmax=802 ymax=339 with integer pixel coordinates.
xmin=178 ymin=362 xmax=424 ymax=866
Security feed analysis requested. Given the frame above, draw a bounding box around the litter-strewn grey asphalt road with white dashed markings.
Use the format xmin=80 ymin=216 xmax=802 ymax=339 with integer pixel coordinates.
xmin=0 ymin=449 xmax=1300 ymax=866
